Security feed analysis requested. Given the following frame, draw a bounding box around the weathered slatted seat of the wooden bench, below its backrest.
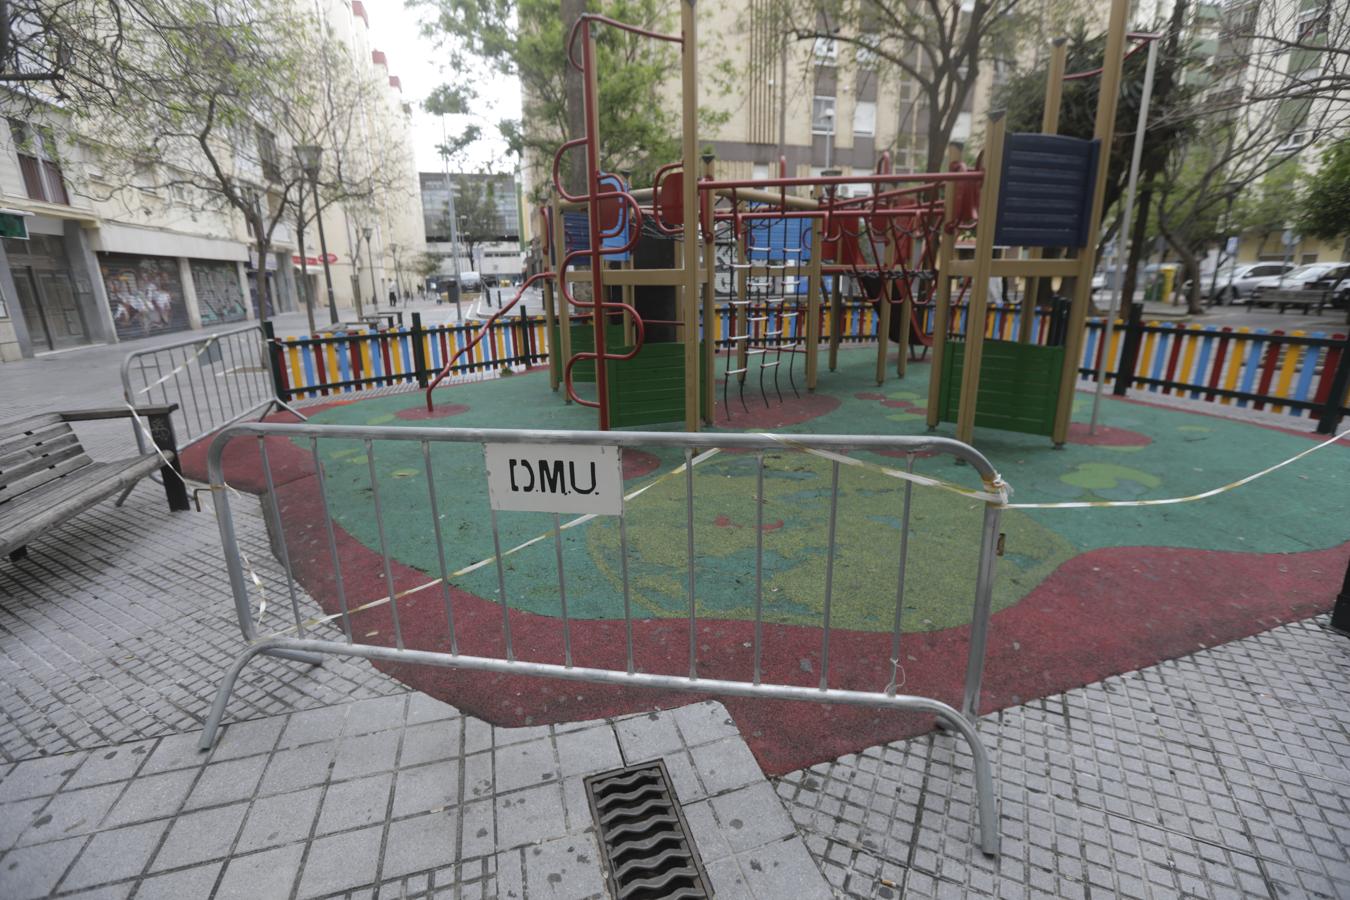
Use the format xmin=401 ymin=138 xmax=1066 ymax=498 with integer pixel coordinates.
xmin=0 ymin=453 xmax=162 ymax=555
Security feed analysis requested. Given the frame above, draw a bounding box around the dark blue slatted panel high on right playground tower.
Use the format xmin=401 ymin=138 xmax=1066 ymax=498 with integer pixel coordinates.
xmin=994 ymin=134 xmax=1102 ymax=247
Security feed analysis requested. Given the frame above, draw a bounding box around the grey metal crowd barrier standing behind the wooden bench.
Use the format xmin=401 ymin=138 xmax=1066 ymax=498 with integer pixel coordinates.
xmin=122 ymin=325 xmax=304 ymax=452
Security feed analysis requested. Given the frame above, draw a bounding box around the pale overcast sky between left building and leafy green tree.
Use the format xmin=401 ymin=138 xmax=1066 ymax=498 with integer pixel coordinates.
xmin=366 ymin=0 xmax=520 ymax=171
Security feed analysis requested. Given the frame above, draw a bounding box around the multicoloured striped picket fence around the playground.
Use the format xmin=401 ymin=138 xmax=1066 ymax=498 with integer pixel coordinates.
xmin=265 ymin=302 xmax=1350 ymax=429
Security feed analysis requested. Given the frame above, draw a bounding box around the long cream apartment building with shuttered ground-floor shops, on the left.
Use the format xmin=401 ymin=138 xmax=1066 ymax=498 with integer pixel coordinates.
xmin=0 ymin=0 xmax=423 ymax=360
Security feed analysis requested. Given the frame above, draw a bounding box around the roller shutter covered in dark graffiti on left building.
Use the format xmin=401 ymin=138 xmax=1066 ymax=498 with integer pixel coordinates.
xmin=99 ymin=254 xmax=192 ymax=340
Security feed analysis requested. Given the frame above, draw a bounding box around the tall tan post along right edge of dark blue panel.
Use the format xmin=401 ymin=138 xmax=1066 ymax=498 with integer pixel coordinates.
xmin=1050 ymin=0 xmax=1130 ymax=447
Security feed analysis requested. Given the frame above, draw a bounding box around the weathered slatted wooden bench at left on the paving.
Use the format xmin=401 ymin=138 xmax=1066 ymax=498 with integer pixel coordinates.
xmin=0 ymin=405 xmax=188 ymax=560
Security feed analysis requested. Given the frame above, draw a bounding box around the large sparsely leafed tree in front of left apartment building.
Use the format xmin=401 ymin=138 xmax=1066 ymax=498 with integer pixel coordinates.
xmin=0 ymin=0 xmax=408 ymax=323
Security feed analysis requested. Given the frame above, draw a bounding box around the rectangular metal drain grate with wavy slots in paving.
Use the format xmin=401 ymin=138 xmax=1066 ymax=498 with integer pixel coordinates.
xmin=586 ymin=760 xmax=713 ymax=900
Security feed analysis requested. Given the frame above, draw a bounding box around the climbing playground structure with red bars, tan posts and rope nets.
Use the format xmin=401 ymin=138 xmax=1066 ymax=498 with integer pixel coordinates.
xmin=427 ymin=0 xmax=1153 ymax=445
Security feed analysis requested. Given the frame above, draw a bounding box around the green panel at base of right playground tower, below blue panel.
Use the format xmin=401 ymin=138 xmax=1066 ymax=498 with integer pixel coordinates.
xmin=938 ymin=340 xmax=1064 ymax=434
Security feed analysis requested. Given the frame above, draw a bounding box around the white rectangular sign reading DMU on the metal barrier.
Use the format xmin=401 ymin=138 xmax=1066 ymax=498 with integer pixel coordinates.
xmin=483 ymin=444 xmax=624 ymax=515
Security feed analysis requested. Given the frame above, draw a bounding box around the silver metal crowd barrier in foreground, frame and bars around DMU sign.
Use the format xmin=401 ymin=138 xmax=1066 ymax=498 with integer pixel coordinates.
xmin=201 ymin=422 xmax=1003 ymax=854
